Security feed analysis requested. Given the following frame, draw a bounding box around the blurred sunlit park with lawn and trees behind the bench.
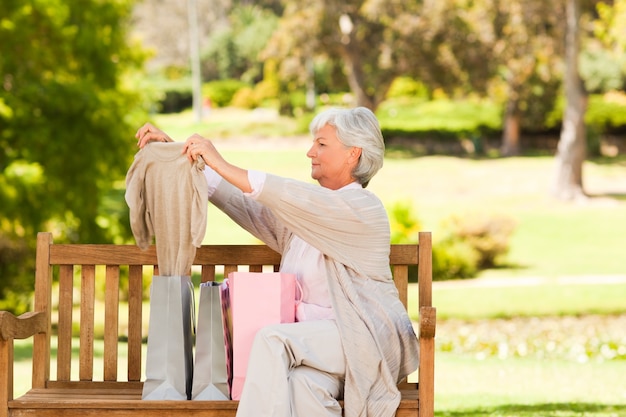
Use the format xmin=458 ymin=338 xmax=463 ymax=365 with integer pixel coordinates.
xmin=0 ymin=0 xmax=626 ymax=417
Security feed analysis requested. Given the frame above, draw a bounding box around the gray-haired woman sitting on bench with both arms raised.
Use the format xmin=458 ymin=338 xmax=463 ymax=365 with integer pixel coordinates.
xmin=137 ymin=108 xmax=419 ymax=417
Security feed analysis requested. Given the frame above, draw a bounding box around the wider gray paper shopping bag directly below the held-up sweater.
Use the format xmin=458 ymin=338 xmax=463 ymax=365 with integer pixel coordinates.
xmin=142 ymin=276 xmax=194 ymax=400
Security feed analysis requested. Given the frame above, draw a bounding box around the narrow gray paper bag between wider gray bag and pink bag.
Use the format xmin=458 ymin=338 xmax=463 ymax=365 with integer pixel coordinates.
xmin=191 ymin=282 xmax=230 ymax=400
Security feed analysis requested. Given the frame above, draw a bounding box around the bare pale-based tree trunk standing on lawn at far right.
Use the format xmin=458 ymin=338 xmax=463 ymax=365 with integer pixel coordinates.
xmin=552 ymin=0 xmax=587 ymax=200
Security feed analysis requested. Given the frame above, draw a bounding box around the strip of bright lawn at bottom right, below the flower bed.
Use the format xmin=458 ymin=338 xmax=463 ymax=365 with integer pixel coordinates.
xmin=435 ymin=352 xmax=626 ymax=417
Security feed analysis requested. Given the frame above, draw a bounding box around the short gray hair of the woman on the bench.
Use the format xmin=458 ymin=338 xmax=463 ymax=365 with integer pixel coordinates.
xmin=309 ymin=107 xmax=385 ymax=187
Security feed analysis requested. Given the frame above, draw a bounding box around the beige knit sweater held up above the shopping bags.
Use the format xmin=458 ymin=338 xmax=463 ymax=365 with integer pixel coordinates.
xmin=125 ymin=142 xmax=208 ymax=276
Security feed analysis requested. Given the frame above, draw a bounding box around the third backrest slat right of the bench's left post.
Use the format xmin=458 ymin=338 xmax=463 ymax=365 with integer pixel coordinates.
xmin=104 ymin=265 xmax=120 ymax=381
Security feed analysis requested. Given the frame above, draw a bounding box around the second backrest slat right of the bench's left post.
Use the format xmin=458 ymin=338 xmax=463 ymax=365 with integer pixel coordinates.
xmin=78 ymin=265 xmax=96 ymax=381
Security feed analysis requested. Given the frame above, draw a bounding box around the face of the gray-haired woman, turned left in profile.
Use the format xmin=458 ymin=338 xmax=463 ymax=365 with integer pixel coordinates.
xmin=306 ymin=125 xmax=361 ymax=190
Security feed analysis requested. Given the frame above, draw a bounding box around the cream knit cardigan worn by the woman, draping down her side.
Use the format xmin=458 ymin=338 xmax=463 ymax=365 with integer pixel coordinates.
xmin=209 ymin=174 xmax=419 ymax=417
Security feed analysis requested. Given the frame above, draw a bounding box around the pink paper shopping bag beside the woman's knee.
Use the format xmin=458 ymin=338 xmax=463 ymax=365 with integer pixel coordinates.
xmin=228 ymin=272 xmax=296 ymax=400
